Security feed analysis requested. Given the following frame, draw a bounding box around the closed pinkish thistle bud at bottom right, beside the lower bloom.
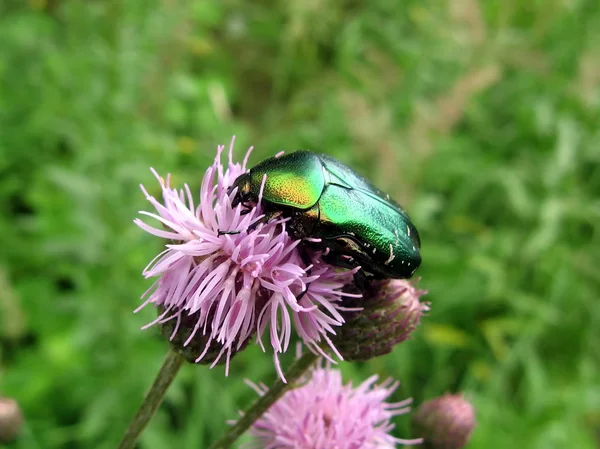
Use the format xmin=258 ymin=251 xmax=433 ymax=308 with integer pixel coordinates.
xmin=413 ymin=394 xmax=475 ymax=449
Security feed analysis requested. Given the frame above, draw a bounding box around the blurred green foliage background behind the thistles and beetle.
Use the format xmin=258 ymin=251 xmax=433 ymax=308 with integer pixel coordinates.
xmin=0 ymin=0 xmax=600 ymax=449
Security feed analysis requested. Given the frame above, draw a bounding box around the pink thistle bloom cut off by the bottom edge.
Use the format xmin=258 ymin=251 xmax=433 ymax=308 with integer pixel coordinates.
xmin=249 ymin=365 xmax=422 ymax=449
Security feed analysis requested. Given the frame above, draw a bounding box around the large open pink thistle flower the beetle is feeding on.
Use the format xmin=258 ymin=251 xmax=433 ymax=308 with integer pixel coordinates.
xmin=135 ymin=138 xmax=352 ymax=378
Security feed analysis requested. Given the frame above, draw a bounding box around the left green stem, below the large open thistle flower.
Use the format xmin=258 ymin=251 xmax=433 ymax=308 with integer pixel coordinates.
xmin=118 ymin=350 xmax=185 ymax=449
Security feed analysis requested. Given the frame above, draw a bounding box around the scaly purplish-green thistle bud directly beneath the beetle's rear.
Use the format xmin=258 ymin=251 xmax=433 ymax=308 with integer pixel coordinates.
xmin=334 ymin=279 xmax=429 ymax=361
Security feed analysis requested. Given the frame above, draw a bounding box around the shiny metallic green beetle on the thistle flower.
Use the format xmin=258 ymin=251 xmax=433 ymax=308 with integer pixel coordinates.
xmin=230 ymin=151 xmax=421 ymax=279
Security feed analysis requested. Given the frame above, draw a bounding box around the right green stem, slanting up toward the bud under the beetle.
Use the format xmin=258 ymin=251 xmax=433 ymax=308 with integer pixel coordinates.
xmin=209 ymin=351 xmax=318 ymax=449
